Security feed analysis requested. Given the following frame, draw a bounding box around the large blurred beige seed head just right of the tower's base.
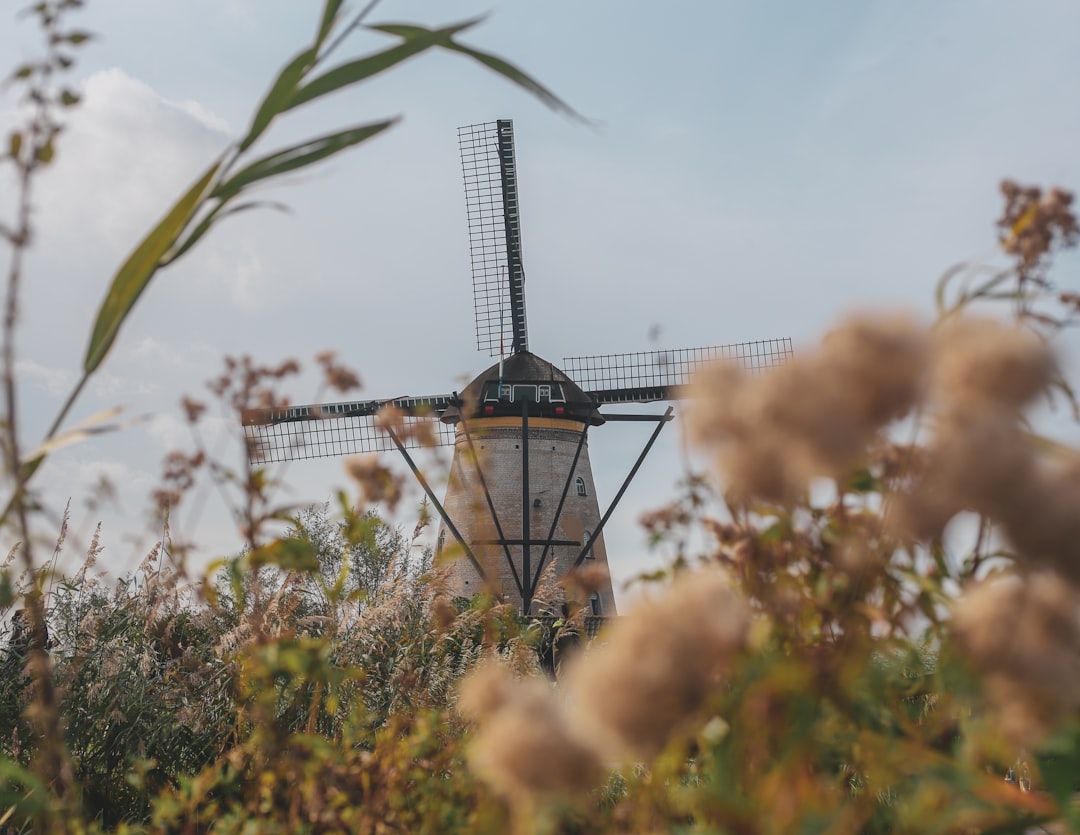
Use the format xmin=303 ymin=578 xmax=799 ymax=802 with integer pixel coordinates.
xmin=567 ymin=569 xmax=750 ymax=758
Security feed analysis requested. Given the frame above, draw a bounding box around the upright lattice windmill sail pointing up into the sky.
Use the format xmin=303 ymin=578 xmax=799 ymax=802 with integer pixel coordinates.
xmin=458 ymin=119 xmax=529 ymax=356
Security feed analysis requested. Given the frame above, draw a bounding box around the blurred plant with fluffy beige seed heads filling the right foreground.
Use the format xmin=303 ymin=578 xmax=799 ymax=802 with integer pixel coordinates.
xmin=453 ymin=184 xmax=1080 ymax=833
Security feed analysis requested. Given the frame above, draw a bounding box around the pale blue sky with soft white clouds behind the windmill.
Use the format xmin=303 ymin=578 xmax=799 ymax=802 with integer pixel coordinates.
xmin=0 ymin=0 xmax=1080 ymax=593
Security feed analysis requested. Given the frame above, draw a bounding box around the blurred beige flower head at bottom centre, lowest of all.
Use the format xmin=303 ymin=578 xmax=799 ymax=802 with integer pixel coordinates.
xmin=458 ymin=662 xmax=600 ymax=807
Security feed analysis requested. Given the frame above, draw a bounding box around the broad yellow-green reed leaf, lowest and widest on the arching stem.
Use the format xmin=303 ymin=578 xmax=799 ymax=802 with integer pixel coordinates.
xmin=83 ymin=162 xmax=221 ymax=374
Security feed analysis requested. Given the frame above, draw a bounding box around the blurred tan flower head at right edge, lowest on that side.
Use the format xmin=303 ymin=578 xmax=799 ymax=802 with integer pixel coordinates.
xmin=953 ymin=573 xmax=1080 ymax=748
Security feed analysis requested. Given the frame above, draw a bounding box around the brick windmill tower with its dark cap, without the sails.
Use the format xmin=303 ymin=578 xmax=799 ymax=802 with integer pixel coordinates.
xmin=436 ymin=351 xmax=616 ymax=617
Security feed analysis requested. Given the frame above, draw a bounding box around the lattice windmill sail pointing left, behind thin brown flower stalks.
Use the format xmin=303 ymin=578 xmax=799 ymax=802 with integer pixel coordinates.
xmin=243 ymin=394 xmax=454 ymax=463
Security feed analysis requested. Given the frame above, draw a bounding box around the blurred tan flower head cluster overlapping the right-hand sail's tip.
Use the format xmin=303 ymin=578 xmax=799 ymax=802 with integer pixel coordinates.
xmin=689 ymin=308 xmax=928 ymax=503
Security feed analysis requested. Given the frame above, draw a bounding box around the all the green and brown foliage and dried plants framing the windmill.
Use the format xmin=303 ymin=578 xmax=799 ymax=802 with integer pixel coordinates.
xmin=0 ymin=0 xmax=1080 ymax=833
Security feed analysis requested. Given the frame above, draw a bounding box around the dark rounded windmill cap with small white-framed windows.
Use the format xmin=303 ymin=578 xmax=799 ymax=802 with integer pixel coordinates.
xmin=442 ymin=351 xmax=604 ymax=426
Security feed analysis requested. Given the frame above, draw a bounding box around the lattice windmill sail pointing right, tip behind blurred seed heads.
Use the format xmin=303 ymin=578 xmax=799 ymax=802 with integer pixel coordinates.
xmin=563 ymin=338 xmax=792 ymax=403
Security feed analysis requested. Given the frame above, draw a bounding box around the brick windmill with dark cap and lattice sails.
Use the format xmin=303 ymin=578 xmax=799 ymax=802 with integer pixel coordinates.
xmin=243 ymin=120 xmax=792 ymax=617
